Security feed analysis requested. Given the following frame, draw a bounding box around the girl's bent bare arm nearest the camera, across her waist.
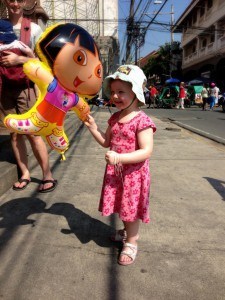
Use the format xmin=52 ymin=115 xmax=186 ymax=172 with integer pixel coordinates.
xmin=105 ymin=128 xmax=153 ymax=165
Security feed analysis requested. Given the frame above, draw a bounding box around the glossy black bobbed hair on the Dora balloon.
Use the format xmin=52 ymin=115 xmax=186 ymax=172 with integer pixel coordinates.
xmin=37 ymin=23 xmax=99 ymax=67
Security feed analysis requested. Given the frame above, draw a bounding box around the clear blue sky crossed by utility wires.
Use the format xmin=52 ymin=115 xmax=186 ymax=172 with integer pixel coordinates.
xmin=118 ymin=0 xmax=191 ymax=59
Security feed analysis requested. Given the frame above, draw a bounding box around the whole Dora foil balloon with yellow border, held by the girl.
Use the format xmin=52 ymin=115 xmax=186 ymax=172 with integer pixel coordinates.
xmin=4 ymin=23 xmax=102 ymax=159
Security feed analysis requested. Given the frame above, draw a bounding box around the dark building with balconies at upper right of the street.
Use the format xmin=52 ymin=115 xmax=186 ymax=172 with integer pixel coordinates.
xmin=173 ymin=0 xmax=225 ymax=86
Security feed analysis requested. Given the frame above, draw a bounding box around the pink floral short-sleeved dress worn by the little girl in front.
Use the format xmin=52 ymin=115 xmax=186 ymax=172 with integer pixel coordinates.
xmin=99 ymin=111 xmax=156 ymax=223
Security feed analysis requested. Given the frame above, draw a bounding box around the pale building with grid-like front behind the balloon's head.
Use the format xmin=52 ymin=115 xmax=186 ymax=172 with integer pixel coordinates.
xmin=0 ymin=0 xmax=119 ymax=76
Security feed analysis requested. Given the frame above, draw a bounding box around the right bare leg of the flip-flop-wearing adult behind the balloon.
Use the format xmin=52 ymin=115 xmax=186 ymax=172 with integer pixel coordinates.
xmin=27 ymin=135 xmax=54 ymax=190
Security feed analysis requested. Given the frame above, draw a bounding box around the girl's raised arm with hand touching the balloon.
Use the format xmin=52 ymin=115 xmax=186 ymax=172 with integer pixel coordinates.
xmin=84 ymin=115 xmax=110 ymax=148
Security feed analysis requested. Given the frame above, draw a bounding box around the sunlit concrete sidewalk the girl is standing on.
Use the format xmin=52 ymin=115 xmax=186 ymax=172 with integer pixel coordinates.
xmin=0 ymin=107 xmax=225 ymax=300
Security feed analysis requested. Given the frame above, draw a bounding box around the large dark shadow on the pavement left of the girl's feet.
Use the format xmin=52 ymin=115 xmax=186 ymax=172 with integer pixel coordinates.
xmin=0 ymin=197 xmax=114 ymax=250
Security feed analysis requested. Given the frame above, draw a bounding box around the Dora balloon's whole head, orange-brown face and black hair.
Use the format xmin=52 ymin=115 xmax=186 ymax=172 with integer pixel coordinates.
xmin=37 ymin=23 xmax=103 ymax=96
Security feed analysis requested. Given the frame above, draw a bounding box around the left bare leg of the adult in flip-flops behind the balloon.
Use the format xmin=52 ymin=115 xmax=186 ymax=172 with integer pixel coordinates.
xmin=11 ymin=133 xmax=30 ymax=188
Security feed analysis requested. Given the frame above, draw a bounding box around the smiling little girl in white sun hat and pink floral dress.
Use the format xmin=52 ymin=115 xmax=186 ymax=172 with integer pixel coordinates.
xmin=85 ymin=65 xmax=156 ymax=265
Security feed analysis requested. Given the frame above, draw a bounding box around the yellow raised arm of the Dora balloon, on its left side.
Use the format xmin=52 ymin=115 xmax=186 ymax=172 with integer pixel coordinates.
xmin=23 ymin=59 xmax=54 ymax=86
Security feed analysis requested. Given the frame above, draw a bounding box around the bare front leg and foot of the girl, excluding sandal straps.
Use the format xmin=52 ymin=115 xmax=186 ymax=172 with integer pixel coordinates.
xmin=119 ymin=220 xmax=140 ymax=262
